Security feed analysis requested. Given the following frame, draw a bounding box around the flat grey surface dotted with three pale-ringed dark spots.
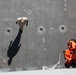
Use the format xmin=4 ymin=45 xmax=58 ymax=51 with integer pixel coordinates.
xmin=0 ymin=0 xmax=76 ymax=69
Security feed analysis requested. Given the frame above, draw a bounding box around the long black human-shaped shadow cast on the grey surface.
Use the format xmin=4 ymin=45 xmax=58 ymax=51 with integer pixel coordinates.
xmin=7 ymin=29 xmax=23 ymax=66
